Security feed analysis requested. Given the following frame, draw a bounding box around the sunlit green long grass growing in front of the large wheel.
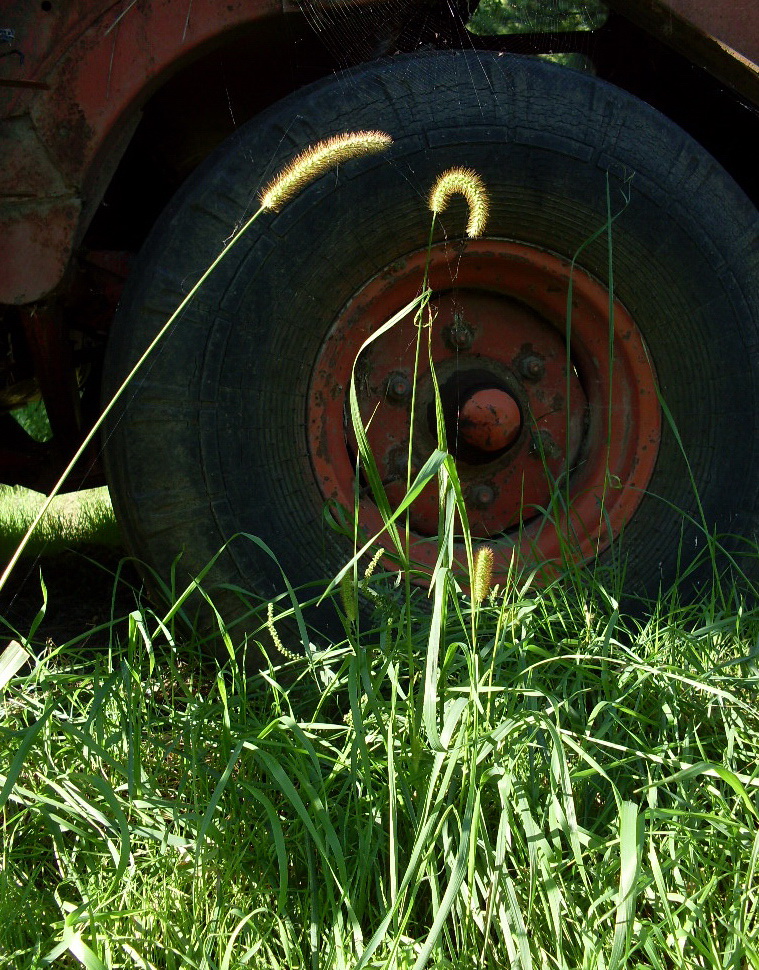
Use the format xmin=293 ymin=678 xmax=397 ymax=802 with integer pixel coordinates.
xmin=0 ymin=573 xmax=759 ymax=968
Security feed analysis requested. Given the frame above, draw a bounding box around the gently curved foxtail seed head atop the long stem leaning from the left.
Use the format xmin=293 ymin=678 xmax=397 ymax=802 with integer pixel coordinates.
xmin=259 ymin=131 xmax=393 ymax=212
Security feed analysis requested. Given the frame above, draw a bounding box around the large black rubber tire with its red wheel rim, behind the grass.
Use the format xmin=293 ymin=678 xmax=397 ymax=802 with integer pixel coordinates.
xmin=105 ymin=51 xmax=759 ymax=644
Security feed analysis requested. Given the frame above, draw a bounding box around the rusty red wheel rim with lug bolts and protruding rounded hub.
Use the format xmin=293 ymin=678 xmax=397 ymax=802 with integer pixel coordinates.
xmin=308 ymin=240 xmax=661 ymax=578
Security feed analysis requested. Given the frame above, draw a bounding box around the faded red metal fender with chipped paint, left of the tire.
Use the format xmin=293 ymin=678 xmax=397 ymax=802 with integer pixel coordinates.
xmin=0 ymin=0 xmax=281 ymax=304
